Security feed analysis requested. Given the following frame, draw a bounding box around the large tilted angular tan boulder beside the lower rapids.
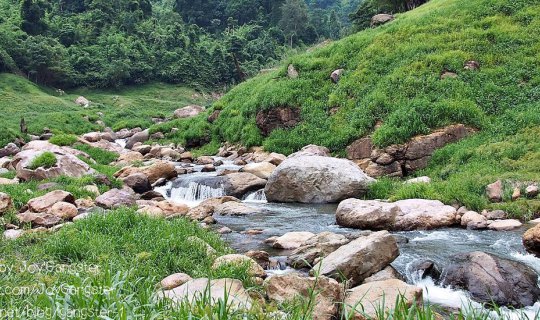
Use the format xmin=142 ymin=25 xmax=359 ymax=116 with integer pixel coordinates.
xmin=312 ymin=231 xmax=399 ymax=285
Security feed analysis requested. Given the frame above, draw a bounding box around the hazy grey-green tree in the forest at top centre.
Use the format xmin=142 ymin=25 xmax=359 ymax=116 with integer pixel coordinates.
xmin=279 ymin=0 xmax=309 ymax=47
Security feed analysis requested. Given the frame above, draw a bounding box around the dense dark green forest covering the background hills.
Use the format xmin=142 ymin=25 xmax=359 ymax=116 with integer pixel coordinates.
xmin=0 ymin=0 xmax=360 ymax=89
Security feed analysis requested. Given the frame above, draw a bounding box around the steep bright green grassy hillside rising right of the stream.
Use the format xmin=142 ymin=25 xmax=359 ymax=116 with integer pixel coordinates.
xmin=152 ymin=0 xmax=540 ymax=215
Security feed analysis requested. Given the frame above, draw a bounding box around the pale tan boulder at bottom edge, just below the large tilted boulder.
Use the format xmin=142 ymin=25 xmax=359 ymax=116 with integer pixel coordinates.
xmin=345 ymin=279 xmax=423 ymax=320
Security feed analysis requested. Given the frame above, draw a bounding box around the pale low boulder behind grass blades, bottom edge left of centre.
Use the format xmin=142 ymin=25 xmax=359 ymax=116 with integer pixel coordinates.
xmin=161 ymin=278 xmax=252 ymax=310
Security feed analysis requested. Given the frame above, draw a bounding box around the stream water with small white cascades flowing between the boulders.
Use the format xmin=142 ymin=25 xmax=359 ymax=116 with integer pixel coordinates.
xmin=156 ymin=158 xmax=540 ymax=319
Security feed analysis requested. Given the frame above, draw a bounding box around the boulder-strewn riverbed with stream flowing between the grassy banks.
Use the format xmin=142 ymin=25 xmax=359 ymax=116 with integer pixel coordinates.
xmin=0 ymin=131 xmax=540 ymax=319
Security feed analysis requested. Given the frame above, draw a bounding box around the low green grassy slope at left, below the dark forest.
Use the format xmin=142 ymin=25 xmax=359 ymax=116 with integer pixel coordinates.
xmin=0 ymin=74 xmax=209 ymax=145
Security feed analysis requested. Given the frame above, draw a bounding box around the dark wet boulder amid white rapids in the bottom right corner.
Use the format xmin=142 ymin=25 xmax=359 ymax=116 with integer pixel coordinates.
xmin=442 ymin=251 xmax=540 ymax=308
